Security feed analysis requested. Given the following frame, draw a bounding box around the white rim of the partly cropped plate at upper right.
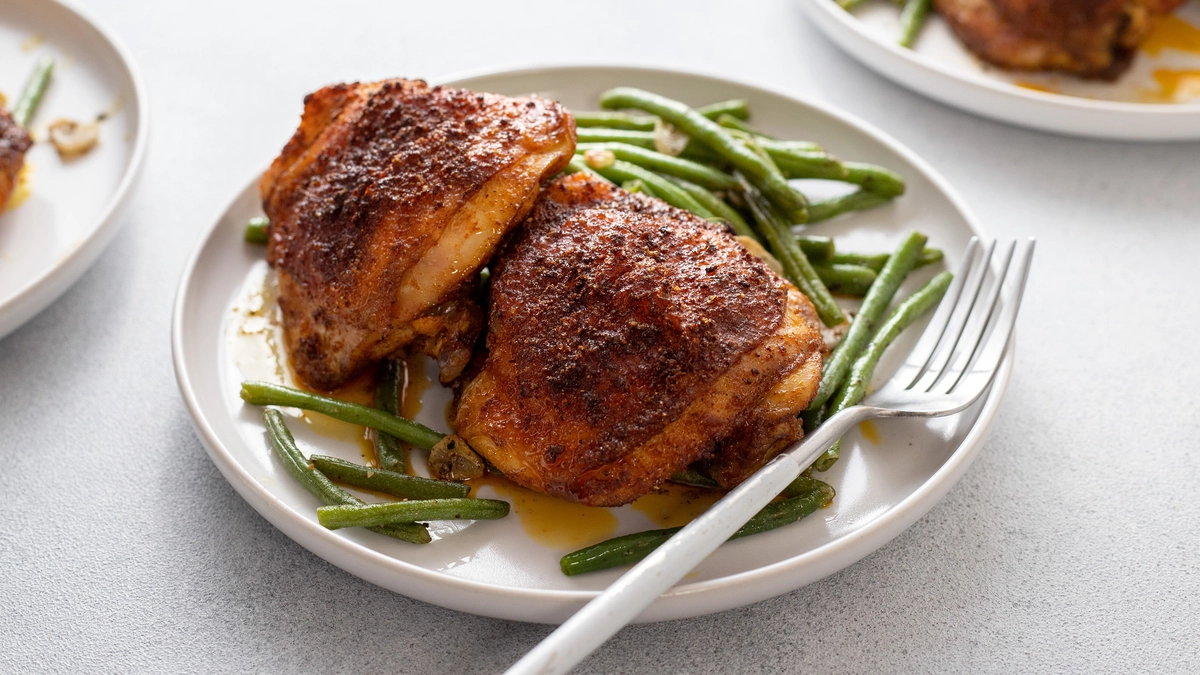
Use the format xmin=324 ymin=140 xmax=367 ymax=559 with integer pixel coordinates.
xmin=800 ymin=0 xmax=1200 ymax=141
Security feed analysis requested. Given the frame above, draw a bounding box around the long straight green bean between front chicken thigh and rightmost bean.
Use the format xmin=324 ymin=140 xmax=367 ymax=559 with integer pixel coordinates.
xmin=809 ymin=232 xmax=926 ymax=410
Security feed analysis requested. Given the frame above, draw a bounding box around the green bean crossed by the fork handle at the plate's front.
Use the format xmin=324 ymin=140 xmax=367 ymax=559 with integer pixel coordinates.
xmin=558 ymin=480 xmax=834 ymax=577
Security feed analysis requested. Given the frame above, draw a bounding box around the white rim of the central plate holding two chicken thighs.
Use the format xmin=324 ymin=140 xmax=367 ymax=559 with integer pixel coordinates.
xmin=172 ymin=62 xmax=1015 ymax=622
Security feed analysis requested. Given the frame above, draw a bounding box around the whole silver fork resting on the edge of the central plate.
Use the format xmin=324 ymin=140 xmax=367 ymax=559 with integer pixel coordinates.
xmin=508 ymin=238 xmax=1033 ymax=675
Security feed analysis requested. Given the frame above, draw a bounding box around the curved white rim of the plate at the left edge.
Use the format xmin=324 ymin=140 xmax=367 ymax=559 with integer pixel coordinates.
xmin=0 ymin=0 xmax=150 ymax=339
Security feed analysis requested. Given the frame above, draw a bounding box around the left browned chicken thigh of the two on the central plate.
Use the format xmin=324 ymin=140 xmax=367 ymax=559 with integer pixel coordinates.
xmin=260 ymin=79 xmax=575 ymax=389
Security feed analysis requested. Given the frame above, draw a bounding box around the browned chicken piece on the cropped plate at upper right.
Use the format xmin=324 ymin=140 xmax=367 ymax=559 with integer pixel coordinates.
xmin=934 ymin=0 xmax=1183 ymax=79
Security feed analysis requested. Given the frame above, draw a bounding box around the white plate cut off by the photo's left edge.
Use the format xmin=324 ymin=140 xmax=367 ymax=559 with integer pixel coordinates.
xmin=0 ymin=0 xmax=148 ymax=338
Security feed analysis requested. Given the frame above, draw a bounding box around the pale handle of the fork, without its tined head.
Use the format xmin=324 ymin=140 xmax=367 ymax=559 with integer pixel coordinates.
xmin=506 ymin=406 xmax=878 ymax=675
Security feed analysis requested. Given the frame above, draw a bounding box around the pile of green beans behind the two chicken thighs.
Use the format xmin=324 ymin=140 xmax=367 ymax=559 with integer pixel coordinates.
xmin=566 ymin=86 xmax=905 ymax=327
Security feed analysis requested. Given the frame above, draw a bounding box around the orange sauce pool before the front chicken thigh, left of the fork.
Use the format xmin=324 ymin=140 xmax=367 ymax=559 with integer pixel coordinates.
xmin=468 ymin=474 xmax=618 ymax=552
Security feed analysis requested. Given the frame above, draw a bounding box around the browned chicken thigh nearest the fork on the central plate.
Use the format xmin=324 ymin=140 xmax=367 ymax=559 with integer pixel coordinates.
xmin=455 ymin=173 xmax=824 ymax=506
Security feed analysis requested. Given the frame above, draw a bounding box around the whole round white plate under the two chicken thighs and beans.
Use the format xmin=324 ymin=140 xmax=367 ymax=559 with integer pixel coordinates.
xmin=172 ymin=66 xmax=1012 ymax=622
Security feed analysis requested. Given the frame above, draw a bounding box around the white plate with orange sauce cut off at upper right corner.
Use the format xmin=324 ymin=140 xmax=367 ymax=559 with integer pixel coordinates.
xmin=800 ymin=0 xmax=1200 ymax=141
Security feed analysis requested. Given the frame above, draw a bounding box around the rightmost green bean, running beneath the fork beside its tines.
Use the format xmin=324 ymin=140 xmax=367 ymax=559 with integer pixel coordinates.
xmin=812 ymin=271 xmax=954 ymax=471
